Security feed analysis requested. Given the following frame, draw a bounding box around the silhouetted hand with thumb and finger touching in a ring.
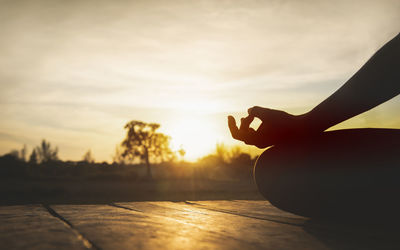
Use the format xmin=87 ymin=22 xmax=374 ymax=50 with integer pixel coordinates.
xmin=228 ymin=106 xmax=307 ymax=148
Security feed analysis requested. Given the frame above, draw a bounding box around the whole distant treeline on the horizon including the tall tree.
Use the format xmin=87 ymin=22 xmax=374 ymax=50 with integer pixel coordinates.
xmin=0 ymin=120 xmax=255 ymax=180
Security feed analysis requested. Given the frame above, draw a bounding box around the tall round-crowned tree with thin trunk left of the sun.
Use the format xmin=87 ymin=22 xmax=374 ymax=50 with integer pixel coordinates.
xmin=121 ymin=121 xmax=173 ymax=179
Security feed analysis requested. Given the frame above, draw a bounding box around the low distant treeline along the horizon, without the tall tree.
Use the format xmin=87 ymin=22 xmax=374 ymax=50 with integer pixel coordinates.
xmin=0 ymin=140 xmax=255 ymax=181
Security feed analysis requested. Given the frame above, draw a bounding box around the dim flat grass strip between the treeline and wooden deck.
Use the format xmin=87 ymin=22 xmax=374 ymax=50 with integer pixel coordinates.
xmin=0 ymin=179 xmax=263 ymax=205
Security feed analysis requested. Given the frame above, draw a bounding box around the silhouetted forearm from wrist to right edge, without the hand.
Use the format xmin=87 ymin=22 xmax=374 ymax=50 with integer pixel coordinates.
xmin=304 ymin=34 xmax=400 ymax=131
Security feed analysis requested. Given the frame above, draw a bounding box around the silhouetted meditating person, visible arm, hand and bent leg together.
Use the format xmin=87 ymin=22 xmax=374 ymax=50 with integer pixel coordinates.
xmin=228 ymin=34 xmax=400 ymax=219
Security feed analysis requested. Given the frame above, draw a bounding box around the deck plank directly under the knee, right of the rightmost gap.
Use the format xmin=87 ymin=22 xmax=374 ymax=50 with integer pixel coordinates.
xmin=190 ymin=200 xmax=400 ymax=249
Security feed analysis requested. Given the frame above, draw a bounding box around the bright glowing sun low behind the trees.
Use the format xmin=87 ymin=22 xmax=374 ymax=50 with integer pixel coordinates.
xmin=165 ymin=116 xmax=220 ymax=161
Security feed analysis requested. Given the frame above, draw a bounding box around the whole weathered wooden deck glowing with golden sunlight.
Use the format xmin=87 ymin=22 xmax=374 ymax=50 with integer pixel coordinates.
xmin=0 ymin=200 xmax=400 ymax=249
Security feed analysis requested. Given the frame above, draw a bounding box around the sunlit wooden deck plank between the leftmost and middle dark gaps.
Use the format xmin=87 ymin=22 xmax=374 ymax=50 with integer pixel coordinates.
xmin=52 ymin=205 xmax=259 ymax=249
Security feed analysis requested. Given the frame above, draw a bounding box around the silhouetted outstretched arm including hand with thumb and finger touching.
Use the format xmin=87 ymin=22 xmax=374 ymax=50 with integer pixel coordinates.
xmin=228 ymin=34 xmax=400 ymax=148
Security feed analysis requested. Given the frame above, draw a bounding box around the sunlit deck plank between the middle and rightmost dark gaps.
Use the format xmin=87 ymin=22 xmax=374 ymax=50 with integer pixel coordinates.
xmin=117 ymin=202 xmax=327 ymax=249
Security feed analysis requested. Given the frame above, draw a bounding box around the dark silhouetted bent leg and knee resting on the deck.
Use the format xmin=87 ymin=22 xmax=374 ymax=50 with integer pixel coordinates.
xmin=254 ymin=129 xmax=400 ymax=218
